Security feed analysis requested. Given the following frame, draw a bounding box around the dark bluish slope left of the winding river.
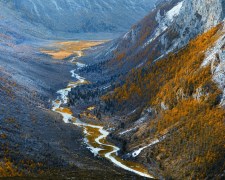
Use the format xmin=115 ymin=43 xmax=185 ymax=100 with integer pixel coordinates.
xmin=0 ymin=39 xmax=146 ymax=179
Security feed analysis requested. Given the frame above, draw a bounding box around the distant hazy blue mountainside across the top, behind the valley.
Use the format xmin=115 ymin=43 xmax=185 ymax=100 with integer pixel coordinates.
xmin=1 ymin=0 xmax=158 ymax=33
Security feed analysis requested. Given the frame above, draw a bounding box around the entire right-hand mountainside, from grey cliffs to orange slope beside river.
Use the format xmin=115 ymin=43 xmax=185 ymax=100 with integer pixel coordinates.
xmin=70 ymin=0 xmax=225 ymax=179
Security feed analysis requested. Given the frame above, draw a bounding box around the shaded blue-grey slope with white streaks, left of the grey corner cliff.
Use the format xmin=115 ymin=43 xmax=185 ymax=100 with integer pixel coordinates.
xmin=89 ymin=0 xmax=183 ymax=72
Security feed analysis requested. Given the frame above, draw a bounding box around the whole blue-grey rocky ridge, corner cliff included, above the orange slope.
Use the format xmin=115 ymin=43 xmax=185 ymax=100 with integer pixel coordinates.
xmin=92 ymin=0 xmax=224 ymax=72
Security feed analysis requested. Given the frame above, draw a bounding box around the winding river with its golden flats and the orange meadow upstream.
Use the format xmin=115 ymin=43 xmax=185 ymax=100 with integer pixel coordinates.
xmin=42 ymin=41 xmax=156 ymax=178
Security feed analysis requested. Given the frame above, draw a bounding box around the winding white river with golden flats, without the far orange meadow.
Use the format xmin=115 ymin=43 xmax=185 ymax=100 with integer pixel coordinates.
xmin=52 ymin=58 xmax=154 ymax=178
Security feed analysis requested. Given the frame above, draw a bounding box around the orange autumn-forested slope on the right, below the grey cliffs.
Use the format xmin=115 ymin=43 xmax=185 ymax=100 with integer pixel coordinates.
xmin=103 ymin=25 xmax=225 ymax=179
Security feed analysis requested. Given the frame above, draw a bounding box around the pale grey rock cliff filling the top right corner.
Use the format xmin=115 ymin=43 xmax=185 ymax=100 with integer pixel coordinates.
xmin=175 ymin=0 xmax=225 ymax=46
